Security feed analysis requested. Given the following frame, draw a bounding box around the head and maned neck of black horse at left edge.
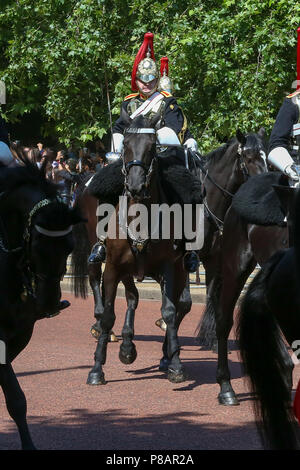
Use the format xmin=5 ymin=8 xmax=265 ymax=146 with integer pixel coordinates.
xmin=0 ymin=160 xmax=83 ymax=317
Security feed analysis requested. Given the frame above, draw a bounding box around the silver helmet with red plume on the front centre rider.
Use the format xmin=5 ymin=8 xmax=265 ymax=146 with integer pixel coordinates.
xmin=131 ymin=33 xmax=158 ymax=91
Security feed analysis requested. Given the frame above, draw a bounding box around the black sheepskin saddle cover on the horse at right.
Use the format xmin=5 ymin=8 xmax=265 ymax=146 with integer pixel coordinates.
xmin=232 ymin=171 xmax=289 ymax=227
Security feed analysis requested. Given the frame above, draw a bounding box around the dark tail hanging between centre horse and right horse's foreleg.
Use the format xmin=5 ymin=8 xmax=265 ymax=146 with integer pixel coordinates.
xmin=195 ymin=275 xmax=222 ymax=349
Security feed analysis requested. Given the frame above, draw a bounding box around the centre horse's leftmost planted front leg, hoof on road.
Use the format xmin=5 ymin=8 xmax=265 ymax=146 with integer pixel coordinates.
xmin=87 ymin=263 xmax=119 ymax=385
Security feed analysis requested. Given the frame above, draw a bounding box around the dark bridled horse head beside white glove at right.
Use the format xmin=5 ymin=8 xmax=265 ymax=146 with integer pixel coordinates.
xmin=236 ymin=127 xmax=268 ymax=180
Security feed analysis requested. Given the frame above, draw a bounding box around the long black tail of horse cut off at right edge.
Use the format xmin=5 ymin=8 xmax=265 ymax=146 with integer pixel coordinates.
xmin=236 ymin=251 xmax=298 ymax=449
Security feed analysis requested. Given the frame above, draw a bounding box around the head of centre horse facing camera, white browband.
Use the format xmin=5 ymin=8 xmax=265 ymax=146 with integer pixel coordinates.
xmin=123 ymin=111 xmax=160 ymax=200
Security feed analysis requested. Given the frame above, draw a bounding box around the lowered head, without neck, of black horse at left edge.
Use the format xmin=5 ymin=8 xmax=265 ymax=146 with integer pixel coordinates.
xmin=25 ymin=199 xmax=83 ymax=315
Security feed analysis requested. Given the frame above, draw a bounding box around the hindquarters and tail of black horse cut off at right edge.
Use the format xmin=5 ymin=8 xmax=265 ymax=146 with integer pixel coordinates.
xmin=237 ymin=186 xmax=300 ymax=450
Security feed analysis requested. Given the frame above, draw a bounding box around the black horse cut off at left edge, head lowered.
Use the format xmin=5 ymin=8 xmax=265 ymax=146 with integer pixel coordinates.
xmin=0 ymin=156 xmax=82 ymax=449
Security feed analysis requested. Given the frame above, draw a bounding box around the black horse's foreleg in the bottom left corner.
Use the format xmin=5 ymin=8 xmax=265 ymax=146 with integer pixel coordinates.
xmin=0 ymin=363 xmax=35 ymax=450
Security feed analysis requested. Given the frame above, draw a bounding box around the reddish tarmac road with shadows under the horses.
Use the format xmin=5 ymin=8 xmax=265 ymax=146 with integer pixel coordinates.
xmin=0 ymin=293 xmax=300 ymax=451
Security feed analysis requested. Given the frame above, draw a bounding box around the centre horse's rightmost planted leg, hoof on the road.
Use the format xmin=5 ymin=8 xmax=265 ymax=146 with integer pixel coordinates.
xmin=161 ymin=263 xmax=186 ymax=383
